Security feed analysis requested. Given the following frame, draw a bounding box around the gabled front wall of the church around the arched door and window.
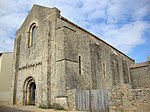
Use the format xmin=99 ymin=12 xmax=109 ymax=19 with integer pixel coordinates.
xmin=11 ymin=5 xmax=59 ymax=105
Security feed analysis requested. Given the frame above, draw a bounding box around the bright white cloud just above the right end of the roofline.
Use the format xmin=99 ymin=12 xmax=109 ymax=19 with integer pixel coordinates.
xmin=104 ymin=21 xmax=150 ymax=53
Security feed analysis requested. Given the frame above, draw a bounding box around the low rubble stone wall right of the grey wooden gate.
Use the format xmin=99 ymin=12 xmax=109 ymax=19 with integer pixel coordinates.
xmin=109 ymin=85 xmax=150 ymax=112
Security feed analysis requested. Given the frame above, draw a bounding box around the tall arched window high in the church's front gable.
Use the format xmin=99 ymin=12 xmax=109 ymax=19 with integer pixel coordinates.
xmin=28 ymin=23 xmax=37 ymax=47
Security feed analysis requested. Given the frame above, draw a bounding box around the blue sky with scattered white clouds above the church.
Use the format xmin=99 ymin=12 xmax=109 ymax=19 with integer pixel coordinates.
xmin=0 ymin=0 xmax=150 ymax=62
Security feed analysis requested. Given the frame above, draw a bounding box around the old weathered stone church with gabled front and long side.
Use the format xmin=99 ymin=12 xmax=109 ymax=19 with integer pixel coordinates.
xmin=11 ymin=5 xmax=150 ymax=112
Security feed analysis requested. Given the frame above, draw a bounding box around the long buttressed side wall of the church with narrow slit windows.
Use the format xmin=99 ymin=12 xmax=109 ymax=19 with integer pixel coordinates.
xmin=56 ymin=17 xmax=134 ymax=109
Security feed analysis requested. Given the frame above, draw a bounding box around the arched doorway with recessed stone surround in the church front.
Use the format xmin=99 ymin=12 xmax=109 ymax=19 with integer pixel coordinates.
xmin=23 ymin=77 xmax=36 ymax=105
